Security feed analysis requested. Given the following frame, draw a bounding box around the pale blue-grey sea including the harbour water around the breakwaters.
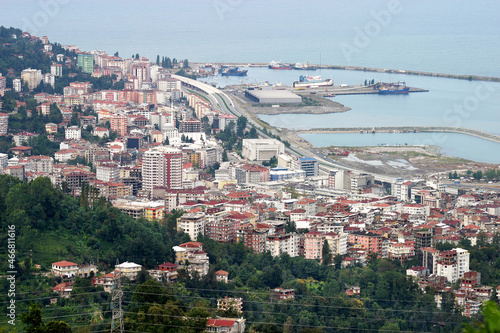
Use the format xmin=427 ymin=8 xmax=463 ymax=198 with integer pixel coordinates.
xmin=0 ymin=0 xmax=500 ymax=164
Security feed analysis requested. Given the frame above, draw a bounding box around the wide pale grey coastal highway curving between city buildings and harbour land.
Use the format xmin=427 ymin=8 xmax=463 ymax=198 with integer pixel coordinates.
xmin=172 ymin=75 xmax=396 ymax=183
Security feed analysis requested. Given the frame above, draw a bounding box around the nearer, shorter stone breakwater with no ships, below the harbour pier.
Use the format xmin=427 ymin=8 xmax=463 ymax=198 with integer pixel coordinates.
xmin=297 ymin=126 xmax=500 ymax=143
